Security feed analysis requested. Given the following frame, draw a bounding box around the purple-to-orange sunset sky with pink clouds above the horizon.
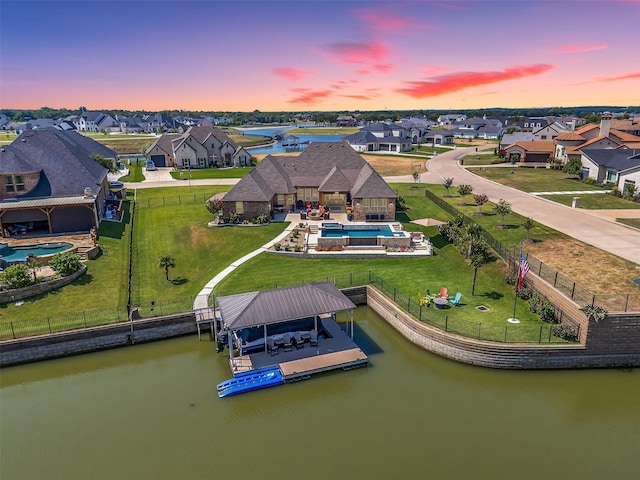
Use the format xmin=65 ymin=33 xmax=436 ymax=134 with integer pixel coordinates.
xmin=0 ymin=0 xmax=640 ymax=112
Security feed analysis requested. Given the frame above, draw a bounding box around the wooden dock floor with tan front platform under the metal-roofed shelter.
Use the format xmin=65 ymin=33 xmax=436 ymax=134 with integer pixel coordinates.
xmin=229 ymin=318 xmax=369 ymax=382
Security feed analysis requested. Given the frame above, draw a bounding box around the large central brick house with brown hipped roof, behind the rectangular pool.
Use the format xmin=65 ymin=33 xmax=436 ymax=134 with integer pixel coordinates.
xmin=222 ymin=141 xmax=397 ymax=221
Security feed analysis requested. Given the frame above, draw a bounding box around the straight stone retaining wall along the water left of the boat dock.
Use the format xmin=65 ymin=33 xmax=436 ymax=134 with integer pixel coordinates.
xmin=0 ymin=312 xmax=197 ymax=367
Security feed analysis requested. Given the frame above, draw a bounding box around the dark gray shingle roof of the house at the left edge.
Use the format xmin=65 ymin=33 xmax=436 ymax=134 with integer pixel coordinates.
xmin=0 ymin=128 xmax=112 ymax=198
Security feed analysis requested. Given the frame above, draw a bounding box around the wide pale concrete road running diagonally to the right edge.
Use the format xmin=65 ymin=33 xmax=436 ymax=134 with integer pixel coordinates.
xmin=420 ymin=148 xmax=640 ymax=264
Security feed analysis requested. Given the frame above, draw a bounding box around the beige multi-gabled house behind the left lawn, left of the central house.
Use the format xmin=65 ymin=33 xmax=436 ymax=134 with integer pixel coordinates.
xmin=145 ymin=125 xmax=251 ymax=168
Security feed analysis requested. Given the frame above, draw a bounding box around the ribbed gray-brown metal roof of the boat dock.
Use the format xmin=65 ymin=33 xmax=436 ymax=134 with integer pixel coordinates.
xmin=218 ymin=282 xmax=356 ymax=330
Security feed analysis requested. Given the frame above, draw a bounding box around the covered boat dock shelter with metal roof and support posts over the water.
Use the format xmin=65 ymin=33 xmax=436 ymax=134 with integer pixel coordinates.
xmin=217 ymin=282 xmax=356 ymax=362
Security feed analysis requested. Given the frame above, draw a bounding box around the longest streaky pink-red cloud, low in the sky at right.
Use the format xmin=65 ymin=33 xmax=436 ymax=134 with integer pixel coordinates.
xmin=396 ymin=65 xmax=554 ymax=98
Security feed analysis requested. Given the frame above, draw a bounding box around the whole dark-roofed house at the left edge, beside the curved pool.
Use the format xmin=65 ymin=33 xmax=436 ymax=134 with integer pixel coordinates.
xmin=0 ymin=128 xmax=117 ymax=237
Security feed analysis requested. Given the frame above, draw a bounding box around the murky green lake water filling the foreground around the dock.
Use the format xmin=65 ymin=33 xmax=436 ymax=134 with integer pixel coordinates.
xmin=0 ymin=307 xmax=640 ymax=480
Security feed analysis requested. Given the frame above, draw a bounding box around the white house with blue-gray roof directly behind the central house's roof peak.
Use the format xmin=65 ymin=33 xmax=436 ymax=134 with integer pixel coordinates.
xmin=344 ymin=123 xmax=411 ymax=152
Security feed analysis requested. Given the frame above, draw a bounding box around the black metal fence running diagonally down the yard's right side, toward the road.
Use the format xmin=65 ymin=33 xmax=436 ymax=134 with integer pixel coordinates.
xmin=425 ymin=189 xmax=640 ymax=312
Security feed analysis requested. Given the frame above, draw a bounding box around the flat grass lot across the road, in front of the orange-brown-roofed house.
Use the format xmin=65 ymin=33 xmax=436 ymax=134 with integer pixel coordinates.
xmin=469 ymin=166 xmax=604 ymax=192
